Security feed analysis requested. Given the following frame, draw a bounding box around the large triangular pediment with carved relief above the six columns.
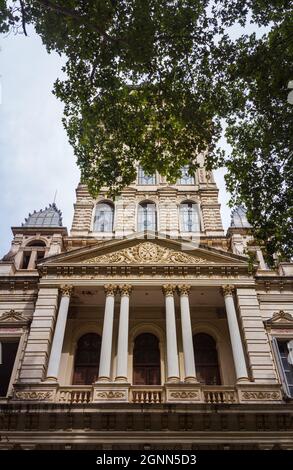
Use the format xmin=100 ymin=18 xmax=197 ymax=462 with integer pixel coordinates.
xmin=40 ymin=232 xmax=247 ymax=266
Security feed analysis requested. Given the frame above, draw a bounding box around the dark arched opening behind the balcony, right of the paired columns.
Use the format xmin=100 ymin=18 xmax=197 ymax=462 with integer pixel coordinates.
xmin=193 ymin=333 xmax=221 ymax=385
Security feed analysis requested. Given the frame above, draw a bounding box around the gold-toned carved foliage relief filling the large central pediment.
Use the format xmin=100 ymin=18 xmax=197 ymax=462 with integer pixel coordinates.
xmin=83 ymin=242 xmax=209 ymax=264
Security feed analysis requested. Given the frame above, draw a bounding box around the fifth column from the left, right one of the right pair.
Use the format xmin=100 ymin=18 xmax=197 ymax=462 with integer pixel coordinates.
xmin=178 ymin=285 xmax=197 ymax=383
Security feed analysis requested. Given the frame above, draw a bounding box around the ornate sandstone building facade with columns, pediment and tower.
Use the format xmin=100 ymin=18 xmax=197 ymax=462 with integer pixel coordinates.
xmin=0 ymin=164 xmax=293 ymax=450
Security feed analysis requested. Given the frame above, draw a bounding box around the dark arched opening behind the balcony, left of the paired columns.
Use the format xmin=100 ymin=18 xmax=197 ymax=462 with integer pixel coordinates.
xmin=73 ymin=333 xmax=101 ymax=385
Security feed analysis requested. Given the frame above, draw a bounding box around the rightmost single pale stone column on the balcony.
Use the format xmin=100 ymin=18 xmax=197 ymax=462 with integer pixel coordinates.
xmin=222 ymin=285 xmax=249 ymax=382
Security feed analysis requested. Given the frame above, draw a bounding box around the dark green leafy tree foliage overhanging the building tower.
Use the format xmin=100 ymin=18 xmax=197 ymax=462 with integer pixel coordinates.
xmin=0 ymin=0 xmax=293 ymax=264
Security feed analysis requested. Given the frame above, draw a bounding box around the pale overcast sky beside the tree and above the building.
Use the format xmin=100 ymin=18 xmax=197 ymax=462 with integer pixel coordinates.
xmin=0 ymin=27 xmax=230 ymax=257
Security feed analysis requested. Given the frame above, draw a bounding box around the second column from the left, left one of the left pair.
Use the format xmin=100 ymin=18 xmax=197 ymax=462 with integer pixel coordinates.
xmin=98 ymin=284 xmax=117 ymax=382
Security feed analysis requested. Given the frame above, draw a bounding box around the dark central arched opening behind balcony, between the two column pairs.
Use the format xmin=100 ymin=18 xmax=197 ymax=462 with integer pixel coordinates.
xmin=133 ymin=333 xmax=161 ymax=385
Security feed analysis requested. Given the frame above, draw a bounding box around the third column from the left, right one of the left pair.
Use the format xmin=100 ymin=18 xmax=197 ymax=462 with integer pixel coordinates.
xmin=115 ymin=284 xmax=131 ymax=382
